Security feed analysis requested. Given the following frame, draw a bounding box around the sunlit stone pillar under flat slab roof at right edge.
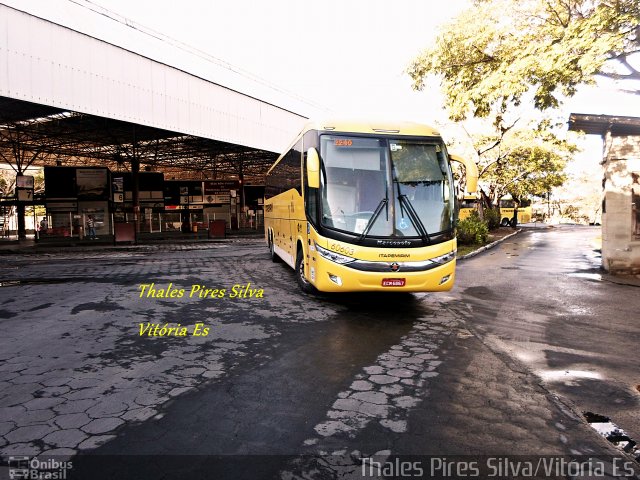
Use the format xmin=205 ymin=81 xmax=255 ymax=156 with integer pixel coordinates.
xmin=602 ymin=133 xmax=640 ymax=274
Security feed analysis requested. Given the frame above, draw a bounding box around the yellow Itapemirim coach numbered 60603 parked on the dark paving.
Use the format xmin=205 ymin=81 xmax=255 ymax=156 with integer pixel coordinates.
xmin=264 ymin=121 xmax=478 ymax=293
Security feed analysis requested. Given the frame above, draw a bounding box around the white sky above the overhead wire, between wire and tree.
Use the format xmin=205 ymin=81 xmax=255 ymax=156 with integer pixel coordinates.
xmin=84 ymin=0 xmax=466 ymax=121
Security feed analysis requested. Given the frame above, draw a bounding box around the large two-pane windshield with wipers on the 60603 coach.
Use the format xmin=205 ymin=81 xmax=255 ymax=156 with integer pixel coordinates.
xmin=320 ymin=135 xmax=453 ymax=240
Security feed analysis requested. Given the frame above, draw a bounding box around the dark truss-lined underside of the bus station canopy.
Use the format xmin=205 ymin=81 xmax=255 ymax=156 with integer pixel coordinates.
xmin=0 ymin=96 xmax=277 ymax=182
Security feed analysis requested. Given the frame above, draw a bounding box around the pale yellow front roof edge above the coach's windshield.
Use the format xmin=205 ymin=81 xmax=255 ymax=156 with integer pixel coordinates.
xmin=302 ymin=119 xmax=440 ymax=137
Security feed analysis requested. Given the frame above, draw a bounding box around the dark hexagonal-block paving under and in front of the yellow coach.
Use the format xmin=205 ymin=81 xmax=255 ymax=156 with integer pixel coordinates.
xmin=0 ymin=232 xmax=640 ymax=479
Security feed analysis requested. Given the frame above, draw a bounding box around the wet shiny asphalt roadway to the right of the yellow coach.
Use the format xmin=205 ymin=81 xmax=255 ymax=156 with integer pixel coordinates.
xmin=452 ymin=226 xmax=640 ymax=458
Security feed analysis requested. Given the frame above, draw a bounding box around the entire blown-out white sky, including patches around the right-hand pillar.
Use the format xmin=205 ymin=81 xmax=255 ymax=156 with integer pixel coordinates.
xmin=0 ymin=0 xmax=640 ymax=171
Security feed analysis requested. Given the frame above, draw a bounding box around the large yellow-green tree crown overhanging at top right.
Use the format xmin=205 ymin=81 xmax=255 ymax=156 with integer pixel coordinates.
xmin=408 ymin=0 xmax=640 ymax=120
